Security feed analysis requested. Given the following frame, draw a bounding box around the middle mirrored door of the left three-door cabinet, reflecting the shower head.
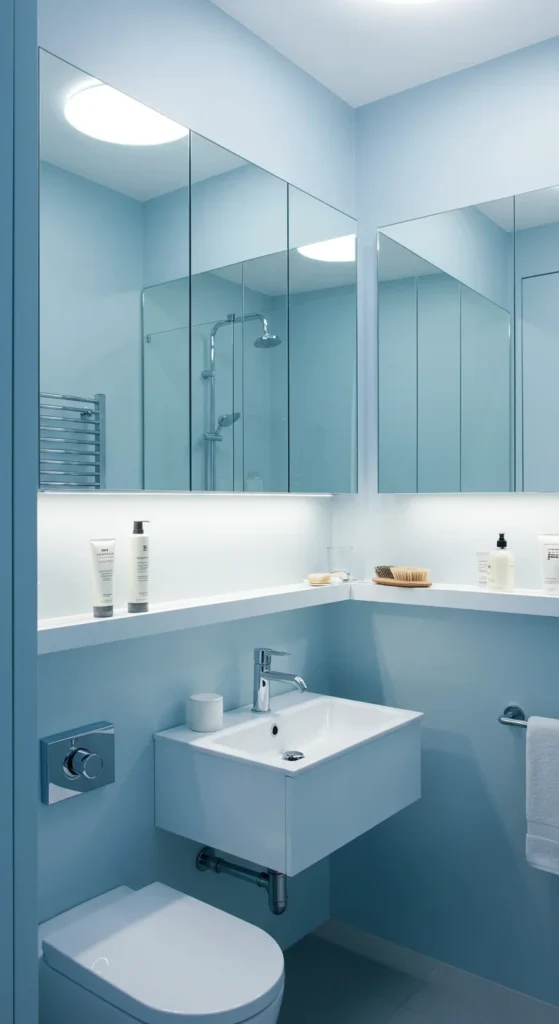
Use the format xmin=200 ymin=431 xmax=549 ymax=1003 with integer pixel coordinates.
xmin=190 ymin=134 xmax=289 ymax=492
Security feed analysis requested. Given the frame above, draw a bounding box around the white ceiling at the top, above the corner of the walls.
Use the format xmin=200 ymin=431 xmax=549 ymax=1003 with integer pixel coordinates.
xmin=213 ymin=0 xmax=559 ymax=106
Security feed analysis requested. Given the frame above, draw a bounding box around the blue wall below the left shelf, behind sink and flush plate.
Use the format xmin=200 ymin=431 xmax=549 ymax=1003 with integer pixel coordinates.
xmin=39 ymin=608 xmax=336 ymax=945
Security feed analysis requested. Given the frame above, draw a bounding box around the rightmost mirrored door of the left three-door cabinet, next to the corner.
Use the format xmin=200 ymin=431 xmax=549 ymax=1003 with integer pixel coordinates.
xmin=289 ymin=191 xmax=357 ymax=493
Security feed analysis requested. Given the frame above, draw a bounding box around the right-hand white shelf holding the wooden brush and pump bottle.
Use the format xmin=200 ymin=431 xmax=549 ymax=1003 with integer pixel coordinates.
xmin=351 ymin=582 xmax=559 ymax=617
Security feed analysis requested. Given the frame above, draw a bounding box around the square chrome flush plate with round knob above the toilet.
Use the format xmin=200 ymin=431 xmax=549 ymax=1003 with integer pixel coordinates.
xmin=41 ymin=722 xmax=115 ymax=804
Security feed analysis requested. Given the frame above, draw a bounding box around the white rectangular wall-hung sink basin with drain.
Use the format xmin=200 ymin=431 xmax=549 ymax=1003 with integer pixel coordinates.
xmin=156 ymin=693 xmax=422 ymax=874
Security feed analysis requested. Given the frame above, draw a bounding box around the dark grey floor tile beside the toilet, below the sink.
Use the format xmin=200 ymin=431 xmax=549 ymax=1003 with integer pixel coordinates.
xmin=280 ymin=936 xmax=424 ymax=1024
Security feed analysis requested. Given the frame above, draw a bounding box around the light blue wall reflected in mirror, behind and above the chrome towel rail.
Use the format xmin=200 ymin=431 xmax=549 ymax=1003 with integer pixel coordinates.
xmin=40 ymin=163 xmax=143 ymax=490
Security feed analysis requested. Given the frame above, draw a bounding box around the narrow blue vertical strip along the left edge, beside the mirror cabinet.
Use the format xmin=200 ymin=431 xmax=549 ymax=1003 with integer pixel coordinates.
xmin=12 ymin=0 xmax=39 ymax=1024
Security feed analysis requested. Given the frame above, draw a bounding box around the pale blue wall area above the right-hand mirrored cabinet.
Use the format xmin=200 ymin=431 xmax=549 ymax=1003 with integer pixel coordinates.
xmin=357 ymin=38 xmax=559 ymax=234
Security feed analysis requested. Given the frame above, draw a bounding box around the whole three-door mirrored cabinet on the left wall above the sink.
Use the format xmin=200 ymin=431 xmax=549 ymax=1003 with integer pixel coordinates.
xmin=40 ymin=52 xmax=356 ymax=493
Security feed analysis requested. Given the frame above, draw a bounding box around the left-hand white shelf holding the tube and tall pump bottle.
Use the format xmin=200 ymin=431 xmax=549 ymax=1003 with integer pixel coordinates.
xmin=38 ymin=583 xmax=350 ymax=654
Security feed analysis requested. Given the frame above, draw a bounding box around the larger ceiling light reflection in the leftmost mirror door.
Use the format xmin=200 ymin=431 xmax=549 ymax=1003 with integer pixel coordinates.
xmin=65 ymin=84 xmax=188 ymax=145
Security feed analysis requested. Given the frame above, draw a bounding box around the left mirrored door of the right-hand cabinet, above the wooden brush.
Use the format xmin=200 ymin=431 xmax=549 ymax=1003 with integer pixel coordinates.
xmin=378 ymin=199 xmax=515 ymax=494
